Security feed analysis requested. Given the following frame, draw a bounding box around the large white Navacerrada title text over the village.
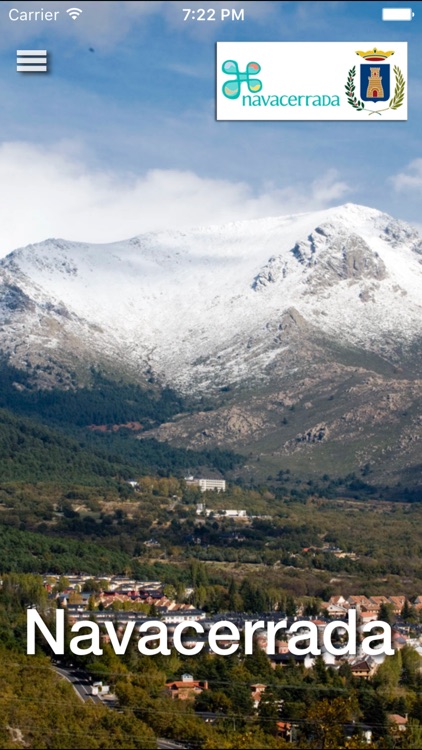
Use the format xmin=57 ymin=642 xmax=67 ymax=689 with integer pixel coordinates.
xmin=27 ymin=609 xmax=394 ymax=656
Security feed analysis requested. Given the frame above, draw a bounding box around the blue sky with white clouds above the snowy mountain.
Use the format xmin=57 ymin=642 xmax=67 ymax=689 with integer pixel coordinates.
xmin=0 ymin=0 xmax=422 ymax=255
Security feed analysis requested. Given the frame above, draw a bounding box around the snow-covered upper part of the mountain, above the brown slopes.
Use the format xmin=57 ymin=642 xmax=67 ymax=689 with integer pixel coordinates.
xmin=0 ymin=204 xmax=422 ymax=392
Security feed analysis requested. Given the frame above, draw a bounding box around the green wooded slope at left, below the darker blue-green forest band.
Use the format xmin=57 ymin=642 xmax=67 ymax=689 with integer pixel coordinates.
xmin=0 ymin=409 xmax=240 ymax=484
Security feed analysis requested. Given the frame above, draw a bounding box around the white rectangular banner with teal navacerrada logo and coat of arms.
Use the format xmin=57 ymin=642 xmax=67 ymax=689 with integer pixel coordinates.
xmin=216 ymin=41 xmax=407 ymax=122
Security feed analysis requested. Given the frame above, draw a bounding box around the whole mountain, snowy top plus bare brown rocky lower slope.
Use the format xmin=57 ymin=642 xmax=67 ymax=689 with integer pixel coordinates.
xmin=0 ymin=204 xmax=422 ymax=488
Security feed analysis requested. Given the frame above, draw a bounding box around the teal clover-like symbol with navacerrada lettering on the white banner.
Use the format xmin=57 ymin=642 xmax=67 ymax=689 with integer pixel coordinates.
xmin=222 ymin=60 xmax=340 ymax=107
